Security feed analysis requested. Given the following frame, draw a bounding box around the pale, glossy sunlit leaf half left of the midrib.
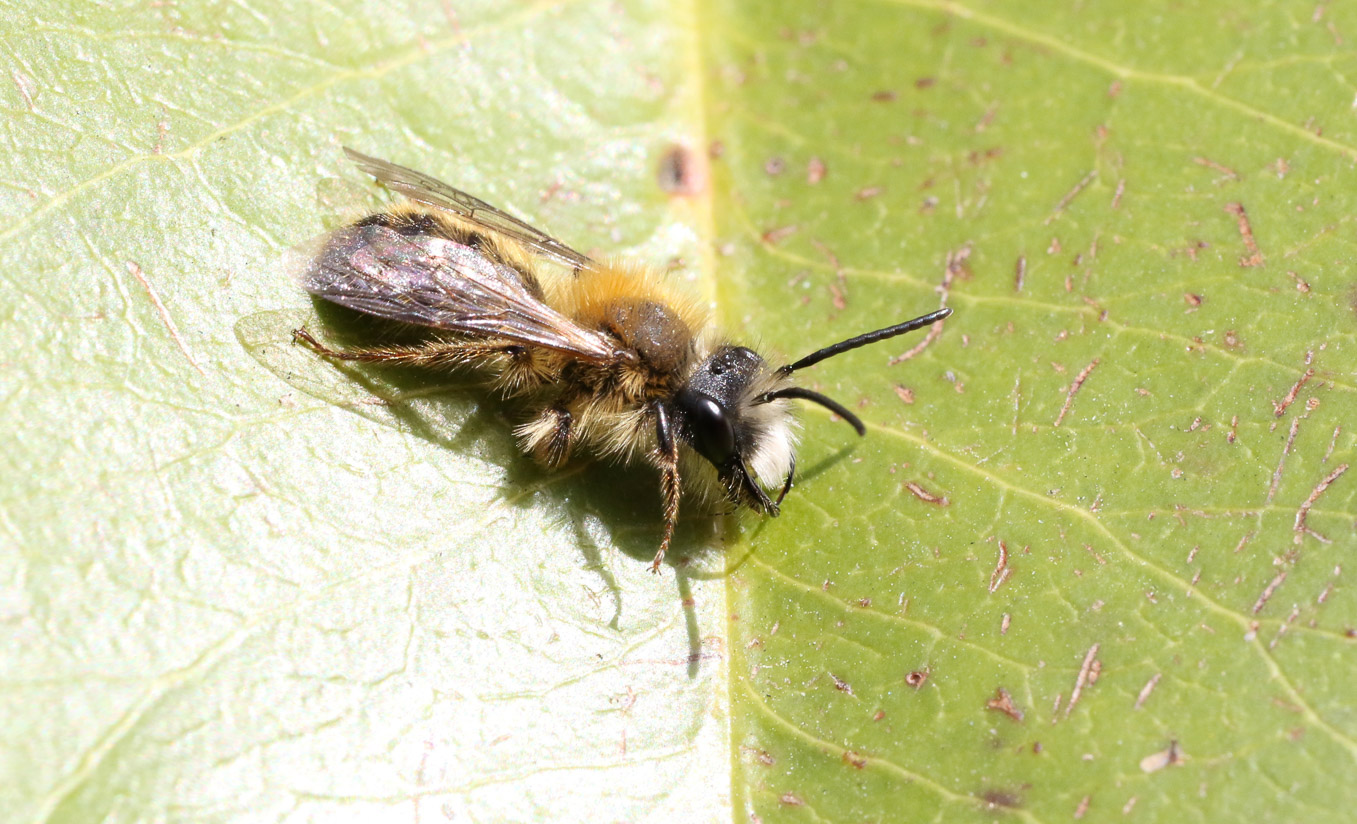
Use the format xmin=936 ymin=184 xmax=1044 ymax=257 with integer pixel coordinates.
xmin=0 ymin=3 xmax=729 ymax=823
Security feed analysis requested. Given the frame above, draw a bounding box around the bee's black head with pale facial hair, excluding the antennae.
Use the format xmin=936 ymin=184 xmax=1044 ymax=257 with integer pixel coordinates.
xmin=674 ymin=346 xmax=792 ymax=514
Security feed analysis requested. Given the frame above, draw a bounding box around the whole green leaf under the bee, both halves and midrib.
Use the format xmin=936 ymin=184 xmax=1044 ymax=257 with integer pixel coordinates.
xmin=0 ymin=1 xmax=1357 ymax=821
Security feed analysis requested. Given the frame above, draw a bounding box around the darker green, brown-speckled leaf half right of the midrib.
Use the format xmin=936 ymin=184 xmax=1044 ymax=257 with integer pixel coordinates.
xmin=708 ymin=3 xmax=1357 ymax=821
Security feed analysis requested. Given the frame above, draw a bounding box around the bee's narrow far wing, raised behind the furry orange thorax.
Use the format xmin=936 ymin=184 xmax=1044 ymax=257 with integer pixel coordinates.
xmin=343 ymin=147 xmax=597 ymax=271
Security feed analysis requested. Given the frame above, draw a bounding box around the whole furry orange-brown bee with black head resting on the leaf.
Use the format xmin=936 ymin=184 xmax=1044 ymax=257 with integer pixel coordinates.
xmin=293 ymin=148 xmax=951 ymax=573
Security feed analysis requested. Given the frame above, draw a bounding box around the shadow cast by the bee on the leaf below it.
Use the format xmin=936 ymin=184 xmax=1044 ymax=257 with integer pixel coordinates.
xmin=235 ymin=301 xmax=781 ymax=675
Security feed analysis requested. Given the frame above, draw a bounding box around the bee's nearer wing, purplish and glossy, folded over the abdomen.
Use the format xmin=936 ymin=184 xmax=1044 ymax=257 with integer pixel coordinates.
xmin=301 ymin=225 xmax=626 ymax=362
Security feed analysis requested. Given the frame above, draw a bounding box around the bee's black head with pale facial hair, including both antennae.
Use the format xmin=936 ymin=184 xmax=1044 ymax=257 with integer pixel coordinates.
xmin=673 ymin=308 xmax=951 ymax=514
